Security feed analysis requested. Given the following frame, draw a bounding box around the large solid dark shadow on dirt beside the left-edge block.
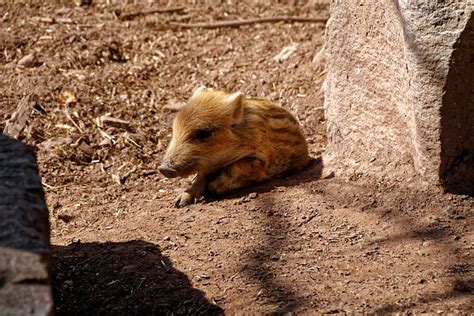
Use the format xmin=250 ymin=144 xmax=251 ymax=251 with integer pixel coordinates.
xmin=52 ymin=240 xmax=223 ymax=315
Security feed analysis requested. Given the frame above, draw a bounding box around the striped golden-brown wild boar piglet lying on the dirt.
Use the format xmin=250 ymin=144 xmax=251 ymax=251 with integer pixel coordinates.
xmin=159 ymin=87 xmax=310 ymax=207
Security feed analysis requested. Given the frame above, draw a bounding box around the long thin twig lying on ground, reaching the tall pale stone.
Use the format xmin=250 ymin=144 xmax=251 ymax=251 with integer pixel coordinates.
xmin=169 ymin=16 xmax=328 ymax=29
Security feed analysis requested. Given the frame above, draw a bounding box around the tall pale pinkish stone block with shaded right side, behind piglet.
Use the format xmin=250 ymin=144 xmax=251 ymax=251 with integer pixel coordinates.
xmin=323 ymin=0 xmax=474 ymax=191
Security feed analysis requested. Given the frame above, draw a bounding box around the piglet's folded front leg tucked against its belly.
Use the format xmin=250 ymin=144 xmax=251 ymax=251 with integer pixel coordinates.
xmin=208 ymin=157 xmax=268 ymax=194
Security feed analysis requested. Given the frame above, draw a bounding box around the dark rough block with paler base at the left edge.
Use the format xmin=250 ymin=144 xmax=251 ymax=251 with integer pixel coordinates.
xmin=0 ymin=134 xmax=53 ymax=316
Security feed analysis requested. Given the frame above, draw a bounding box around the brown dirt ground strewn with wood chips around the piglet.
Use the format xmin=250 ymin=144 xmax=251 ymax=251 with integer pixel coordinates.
xmin=0 ymin=0 xmax=474 ymax=315
